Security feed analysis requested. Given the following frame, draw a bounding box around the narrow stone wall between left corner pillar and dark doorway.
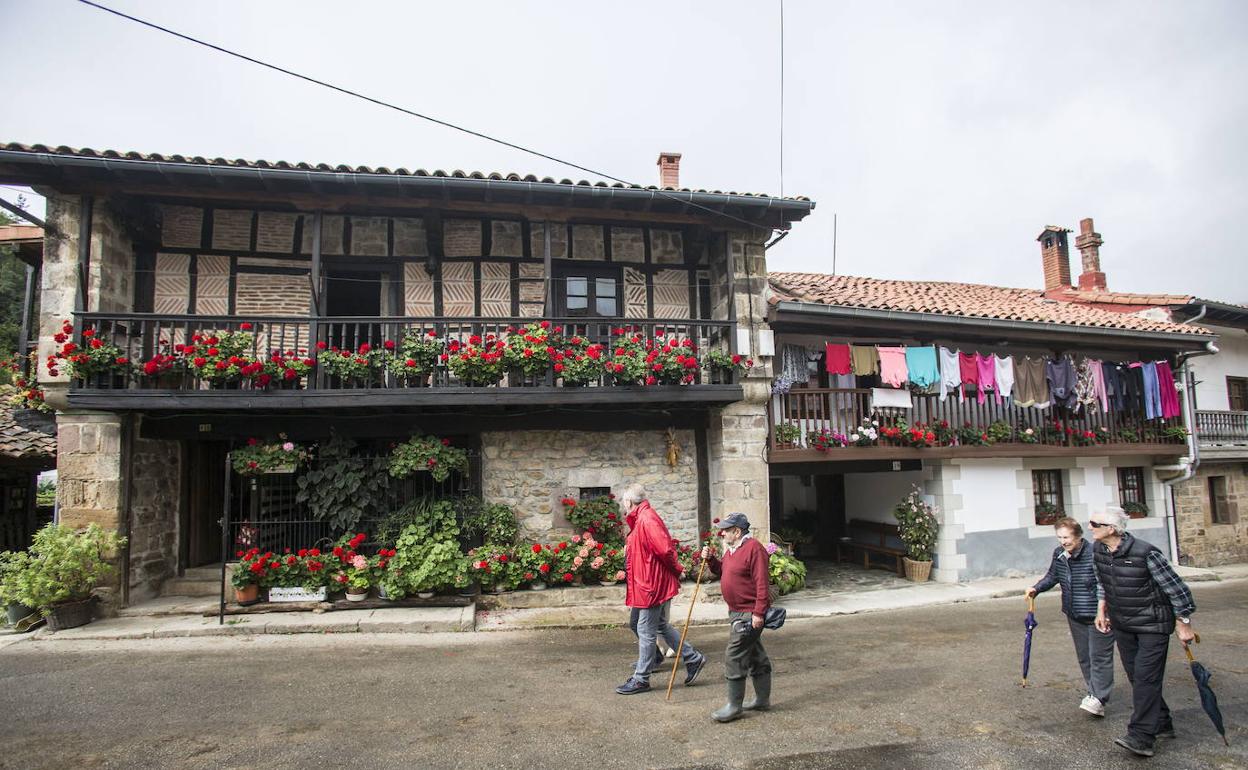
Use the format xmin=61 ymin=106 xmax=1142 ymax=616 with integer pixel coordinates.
xmin=130 ymin=438 xmax=182 ymax=603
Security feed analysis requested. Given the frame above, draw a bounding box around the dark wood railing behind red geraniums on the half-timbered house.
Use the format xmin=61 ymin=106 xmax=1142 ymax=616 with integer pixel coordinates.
xmin=60 ymin=312 xmax=736 ymax=392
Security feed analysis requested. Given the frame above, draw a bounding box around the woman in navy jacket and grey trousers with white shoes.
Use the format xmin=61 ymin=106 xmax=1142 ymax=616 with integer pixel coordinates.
xmin=1027 ymin=517 xmax=1113 ymax=716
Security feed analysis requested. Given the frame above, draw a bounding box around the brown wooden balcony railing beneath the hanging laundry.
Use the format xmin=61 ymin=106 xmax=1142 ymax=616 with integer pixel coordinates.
xmin=769 ymin=388 xmax=1186 ymax=452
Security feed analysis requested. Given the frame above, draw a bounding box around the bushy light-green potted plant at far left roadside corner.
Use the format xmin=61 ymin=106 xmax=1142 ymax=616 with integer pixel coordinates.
xmin=14 ymin=524 xmax=125 ymax=631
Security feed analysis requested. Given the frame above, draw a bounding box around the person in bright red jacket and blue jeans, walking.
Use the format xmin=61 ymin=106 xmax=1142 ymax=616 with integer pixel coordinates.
xmin=615 ymin=484 xmax=706 ymax=695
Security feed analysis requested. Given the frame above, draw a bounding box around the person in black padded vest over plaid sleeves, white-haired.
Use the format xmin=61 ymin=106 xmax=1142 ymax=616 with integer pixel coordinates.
xmin=1088 ymin=508 xmax=1196 ymax=756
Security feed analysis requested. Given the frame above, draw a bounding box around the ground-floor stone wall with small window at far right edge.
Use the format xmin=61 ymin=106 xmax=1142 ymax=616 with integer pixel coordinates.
xmin=1174 ymin=462 xmax=1248 ymax=567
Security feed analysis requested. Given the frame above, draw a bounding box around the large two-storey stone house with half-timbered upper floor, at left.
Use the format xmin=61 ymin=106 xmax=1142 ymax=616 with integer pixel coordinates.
xmin=0 ymin=144 xmax=814 ymax=602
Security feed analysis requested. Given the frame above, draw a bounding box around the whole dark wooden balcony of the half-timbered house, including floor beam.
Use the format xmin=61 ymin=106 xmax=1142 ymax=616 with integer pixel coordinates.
xmin=60 ymin=313 xmax=743 ymax=411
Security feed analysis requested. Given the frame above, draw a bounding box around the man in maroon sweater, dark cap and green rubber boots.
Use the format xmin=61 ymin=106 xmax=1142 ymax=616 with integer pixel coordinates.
xmin=703 ymin=513 xmax=771 ymax=721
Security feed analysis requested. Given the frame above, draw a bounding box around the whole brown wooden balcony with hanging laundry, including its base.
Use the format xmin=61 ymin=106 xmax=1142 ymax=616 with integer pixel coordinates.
xmin=768 ymin=388 xmax=1187 ymax=463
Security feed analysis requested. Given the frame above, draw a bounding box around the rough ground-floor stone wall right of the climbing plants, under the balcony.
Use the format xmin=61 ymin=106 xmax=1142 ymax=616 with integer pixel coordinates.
xmin=482 ymin=431 xmax=703 ymax=540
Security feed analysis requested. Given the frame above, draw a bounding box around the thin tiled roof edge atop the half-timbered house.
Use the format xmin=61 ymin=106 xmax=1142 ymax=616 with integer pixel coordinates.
xmin=0 ymin=142 xmax=810 ymax=201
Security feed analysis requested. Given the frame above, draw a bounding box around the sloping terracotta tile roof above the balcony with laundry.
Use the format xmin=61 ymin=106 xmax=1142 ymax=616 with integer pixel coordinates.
xmin=768 ymin=272 xmax=1209 ymax=334
